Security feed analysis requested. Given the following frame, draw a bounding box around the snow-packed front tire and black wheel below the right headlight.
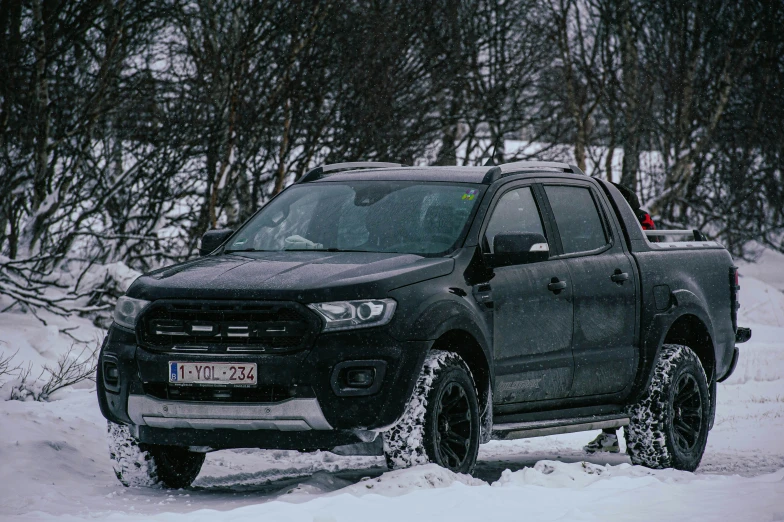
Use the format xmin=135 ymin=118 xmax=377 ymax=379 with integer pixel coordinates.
xmin=383 ymin=350 xmax=481 ymax=473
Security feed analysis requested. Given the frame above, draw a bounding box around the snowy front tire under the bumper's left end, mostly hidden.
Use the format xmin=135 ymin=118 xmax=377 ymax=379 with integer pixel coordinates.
xmin=108 ymin=421 xmax=205 ymax=489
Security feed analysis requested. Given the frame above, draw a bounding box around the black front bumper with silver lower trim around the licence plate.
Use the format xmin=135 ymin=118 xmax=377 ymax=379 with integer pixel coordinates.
xmin=98 ymin=320 xmax=431 ymax=449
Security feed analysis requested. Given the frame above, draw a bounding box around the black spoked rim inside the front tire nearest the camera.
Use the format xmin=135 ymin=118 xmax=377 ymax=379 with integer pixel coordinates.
xmin=433 ymin=381 xmax=473 ymax=470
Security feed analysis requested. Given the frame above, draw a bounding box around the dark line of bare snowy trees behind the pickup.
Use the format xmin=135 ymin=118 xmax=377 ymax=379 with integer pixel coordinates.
xmin=0 ymin=0 xmax=784 ymax=298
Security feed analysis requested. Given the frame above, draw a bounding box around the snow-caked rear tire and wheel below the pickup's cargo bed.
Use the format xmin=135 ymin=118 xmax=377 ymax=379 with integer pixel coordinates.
xmin=624 ymin=344 xmax=711 ymax=471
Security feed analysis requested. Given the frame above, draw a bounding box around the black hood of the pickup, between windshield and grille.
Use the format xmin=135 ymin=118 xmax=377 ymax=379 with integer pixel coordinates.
xmin=127 ymin=252 xmax=454 ymax=303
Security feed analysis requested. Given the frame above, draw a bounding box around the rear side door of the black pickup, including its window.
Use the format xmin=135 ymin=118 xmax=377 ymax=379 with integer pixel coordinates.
xmin=543 ymin=180 xmax=637 ymax=397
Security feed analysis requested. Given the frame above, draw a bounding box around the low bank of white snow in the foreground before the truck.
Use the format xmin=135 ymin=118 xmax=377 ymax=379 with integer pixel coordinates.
xmin=19 ymin=452 xmax=784 ymax=522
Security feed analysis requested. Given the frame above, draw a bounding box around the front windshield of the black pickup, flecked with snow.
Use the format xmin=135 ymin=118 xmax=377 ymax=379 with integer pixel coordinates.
xmin=226 ymin=181 xmax=485 ymax=255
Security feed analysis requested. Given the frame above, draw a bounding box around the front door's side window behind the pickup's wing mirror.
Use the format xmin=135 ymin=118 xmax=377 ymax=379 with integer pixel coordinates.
xmin=485 ymin=187 xmax=545 ymax=253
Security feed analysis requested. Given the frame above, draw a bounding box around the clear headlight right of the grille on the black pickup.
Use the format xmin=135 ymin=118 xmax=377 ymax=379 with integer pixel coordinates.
xmin=308 ymin=299 xmax=397 ymax=332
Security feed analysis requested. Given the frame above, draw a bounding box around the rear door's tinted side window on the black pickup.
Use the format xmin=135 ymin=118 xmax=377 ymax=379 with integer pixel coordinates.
xmin=544 ymin=185 xmax=608 ymax=254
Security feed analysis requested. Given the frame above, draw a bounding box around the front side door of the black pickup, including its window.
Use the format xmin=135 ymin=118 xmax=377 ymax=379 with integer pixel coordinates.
xmin=482 ymin=184 xmax=574 ymax=404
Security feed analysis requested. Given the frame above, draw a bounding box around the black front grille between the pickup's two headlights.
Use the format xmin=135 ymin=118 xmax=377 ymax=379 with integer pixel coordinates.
xmin=137 ymin=300 xmax=320 ymax=353
